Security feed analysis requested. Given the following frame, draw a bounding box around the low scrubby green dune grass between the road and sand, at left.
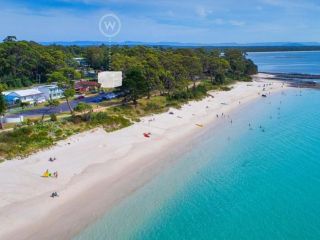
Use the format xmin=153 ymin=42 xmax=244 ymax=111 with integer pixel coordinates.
xmin=0 ymin=112 xmax=132 ymax=160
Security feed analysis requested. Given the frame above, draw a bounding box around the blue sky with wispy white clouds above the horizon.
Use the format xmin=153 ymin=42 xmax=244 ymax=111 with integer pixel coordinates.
xmin=0 ymin=0 xmax=320 ymax=44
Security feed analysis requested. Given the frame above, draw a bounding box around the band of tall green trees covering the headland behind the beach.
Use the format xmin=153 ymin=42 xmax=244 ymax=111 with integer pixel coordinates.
xmin=0 ymin=36 xmax=257 ymax=102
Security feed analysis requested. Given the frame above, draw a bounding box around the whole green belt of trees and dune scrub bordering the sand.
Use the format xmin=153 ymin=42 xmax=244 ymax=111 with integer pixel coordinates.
xmin=0 ymin=37 xmax=257 ymax=159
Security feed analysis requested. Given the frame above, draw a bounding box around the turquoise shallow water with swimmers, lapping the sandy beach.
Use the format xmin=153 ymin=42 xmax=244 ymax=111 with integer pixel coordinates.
xmin=75 ymin=89 xmax=320 ymax=240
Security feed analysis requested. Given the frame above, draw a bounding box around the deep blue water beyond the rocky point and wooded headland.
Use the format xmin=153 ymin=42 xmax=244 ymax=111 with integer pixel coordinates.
xmin=248 ymin=51 xmax=320 ymax=76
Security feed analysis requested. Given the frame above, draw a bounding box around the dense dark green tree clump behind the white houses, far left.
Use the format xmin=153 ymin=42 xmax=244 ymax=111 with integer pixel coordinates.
xmin=0 ymin=39 xmax=72 ymax=87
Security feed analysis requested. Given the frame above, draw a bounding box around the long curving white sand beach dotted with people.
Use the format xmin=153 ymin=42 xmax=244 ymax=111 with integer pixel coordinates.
xmin=0 ymin=74 xmax=287 ymax=240
